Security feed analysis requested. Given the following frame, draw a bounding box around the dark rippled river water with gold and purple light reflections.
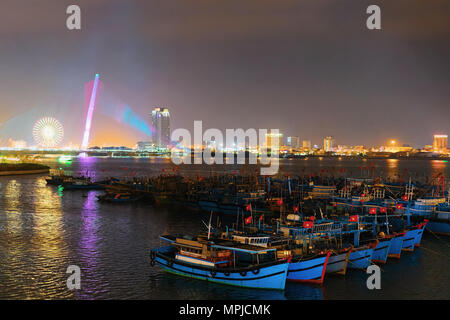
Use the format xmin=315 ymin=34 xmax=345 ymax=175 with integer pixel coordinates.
xmin=0 ymin=158 xmax=450 ymax=299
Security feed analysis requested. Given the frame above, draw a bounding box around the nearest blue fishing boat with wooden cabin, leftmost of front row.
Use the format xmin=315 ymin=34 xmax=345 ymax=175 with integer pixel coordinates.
xmin=151 ymin=235 xmax=289 ymax=290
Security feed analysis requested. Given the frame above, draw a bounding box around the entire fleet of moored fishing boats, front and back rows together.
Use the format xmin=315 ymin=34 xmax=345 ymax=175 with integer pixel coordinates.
xmin=47 ymin=171 xmax=450 ymax=290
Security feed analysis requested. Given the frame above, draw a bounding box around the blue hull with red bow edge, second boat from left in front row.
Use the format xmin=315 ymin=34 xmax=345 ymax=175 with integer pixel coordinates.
xmin=287 ymin=252 xmax=331 ymax=284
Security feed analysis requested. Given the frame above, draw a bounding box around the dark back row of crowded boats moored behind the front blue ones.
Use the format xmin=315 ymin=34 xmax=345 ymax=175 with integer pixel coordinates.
xmin=46 ymin=170 xmax=450 ymax=235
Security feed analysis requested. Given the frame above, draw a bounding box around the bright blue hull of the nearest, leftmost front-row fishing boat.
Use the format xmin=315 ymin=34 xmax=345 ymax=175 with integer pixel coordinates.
xmin=152 ymin=247 xmax=289 ymax=290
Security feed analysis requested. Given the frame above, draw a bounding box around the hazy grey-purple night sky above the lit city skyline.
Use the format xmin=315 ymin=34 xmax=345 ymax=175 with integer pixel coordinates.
xmin=0 ymin=0 xmax=450 ymax=147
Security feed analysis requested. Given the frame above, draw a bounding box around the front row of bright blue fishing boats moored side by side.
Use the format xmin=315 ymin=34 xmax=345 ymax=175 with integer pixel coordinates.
xmin=151 ymin=202 xmax=428 ymax=290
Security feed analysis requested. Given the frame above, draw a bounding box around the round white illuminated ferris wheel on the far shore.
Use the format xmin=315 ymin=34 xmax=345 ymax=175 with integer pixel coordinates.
xmin=33 ymin=117 xmax=64 ymax=148
